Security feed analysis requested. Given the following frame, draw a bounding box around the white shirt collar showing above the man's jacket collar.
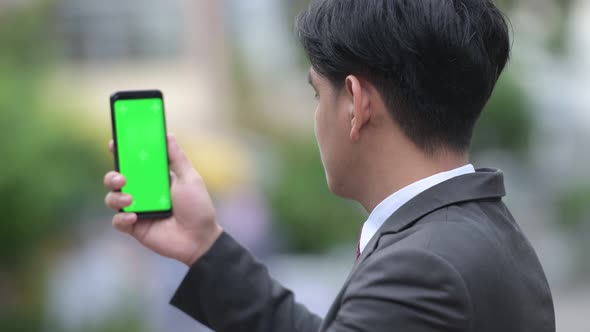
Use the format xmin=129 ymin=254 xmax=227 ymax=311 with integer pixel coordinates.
xmin=359 ymin=164 xmax=475 ymax=253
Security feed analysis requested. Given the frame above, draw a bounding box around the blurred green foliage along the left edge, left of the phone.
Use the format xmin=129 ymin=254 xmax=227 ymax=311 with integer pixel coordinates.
xmin=0 ymin=2 xmax=108 ymax=331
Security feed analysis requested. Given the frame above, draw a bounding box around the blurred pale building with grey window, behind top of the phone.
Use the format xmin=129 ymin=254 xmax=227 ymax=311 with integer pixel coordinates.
xmin=48 ymin=0 xmax=233 ymax=135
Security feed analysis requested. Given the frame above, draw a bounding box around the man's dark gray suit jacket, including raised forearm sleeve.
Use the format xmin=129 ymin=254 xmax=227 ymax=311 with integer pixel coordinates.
xmin=171 ymin=169 xmax=555 ymax=332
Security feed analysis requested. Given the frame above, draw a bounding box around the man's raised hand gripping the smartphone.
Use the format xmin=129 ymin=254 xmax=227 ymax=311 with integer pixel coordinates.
xmin=104 ymin=135 xmax=223 ymax=266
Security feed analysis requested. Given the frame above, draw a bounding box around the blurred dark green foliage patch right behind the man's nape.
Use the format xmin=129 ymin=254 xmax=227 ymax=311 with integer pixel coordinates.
xmin=472 ymin=73 xmax=534 ymax=156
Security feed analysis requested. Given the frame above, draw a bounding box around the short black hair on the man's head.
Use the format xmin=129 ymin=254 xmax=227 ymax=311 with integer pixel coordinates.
xmin=296 ymin=0 xmax=510 ymax=153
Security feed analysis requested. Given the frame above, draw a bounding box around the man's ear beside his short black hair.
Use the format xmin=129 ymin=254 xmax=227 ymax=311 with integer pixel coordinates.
xmin=344 ymin=75 xmax=371 ymax=141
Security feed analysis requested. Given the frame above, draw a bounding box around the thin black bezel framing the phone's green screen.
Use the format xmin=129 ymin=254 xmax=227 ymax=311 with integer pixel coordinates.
xmin=110 ymin=90 xmax=173 ymax=220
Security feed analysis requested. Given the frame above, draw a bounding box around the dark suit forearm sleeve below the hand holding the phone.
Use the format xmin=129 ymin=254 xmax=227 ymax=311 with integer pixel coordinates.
xmin=170 ymin=233 xmax=321 ymax=332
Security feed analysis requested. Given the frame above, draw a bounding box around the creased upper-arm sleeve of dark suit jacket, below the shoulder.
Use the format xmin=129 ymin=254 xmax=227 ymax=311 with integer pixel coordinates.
xmin=326 ymin=249 xmax=471 ymax=332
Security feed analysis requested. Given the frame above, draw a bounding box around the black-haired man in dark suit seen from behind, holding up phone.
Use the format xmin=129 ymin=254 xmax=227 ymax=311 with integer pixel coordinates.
xmin=105 ymin=0 xmax=555 ymax=332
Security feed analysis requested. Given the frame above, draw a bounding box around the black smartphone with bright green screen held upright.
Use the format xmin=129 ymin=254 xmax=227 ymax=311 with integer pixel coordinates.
xmin=111 ymin=90 xmax=172 ymax=219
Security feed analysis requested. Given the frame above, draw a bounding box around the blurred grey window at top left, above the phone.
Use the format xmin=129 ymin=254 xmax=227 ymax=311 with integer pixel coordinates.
xmin=57 ymin=0 xmax=184 ymax=60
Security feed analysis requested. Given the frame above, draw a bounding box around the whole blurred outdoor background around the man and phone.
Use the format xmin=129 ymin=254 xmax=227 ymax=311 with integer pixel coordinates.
xmin=0 ymin=0 xmax=590 ymax=332
